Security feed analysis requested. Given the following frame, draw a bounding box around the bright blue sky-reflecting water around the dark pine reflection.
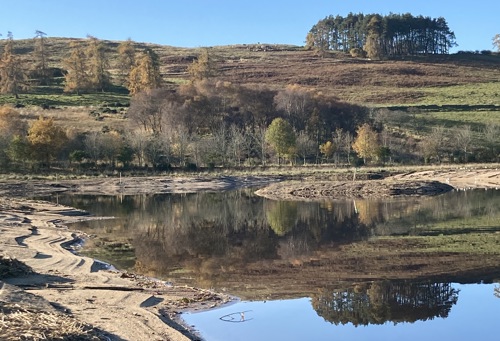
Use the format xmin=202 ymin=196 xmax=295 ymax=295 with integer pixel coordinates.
xmin=183 ymin=284 xmax=500 ymax=341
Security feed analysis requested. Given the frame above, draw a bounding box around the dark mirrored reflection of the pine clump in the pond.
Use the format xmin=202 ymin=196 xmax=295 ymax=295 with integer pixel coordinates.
xmin=312 ymin=282 xmax=459 ymax=326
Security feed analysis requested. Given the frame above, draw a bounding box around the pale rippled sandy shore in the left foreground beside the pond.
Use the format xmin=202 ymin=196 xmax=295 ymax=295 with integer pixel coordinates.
xmin=0 ymin=199 xmax=231 ymax=340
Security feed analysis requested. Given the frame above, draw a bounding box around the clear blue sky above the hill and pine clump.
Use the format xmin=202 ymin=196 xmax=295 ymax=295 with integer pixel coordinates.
xmin=0 ymin=0 xmax=500 ymax=52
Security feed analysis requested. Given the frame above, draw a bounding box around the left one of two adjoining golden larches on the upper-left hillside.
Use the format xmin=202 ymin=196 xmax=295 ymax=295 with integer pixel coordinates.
xmin=63 ymin=41 xmax=89 ymax=95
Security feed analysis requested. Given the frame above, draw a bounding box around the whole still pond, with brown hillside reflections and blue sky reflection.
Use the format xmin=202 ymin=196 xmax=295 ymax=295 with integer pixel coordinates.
xmin=51 ymin=189 xmax=500 ymax=340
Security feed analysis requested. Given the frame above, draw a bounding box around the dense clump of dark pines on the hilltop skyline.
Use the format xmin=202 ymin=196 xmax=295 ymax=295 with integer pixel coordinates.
xmin=306 ymin=13 xmax=456 ymax=58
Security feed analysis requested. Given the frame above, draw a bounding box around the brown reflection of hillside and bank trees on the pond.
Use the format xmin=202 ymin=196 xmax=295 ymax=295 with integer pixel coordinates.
xmin=59 ymin=186 xmax=500 ymax=298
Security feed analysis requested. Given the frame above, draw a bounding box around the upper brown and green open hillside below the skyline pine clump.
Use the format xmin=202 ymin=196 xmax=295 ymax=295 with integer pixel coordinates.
xmin=5 ymin=38 xmax=500 ymax=106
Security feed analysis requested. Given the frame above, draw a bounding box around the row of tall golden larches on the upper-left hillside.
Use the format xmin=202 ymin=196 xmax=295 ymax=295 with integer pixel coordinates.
xmin=0 ymin=31 xmax=162 ymax=98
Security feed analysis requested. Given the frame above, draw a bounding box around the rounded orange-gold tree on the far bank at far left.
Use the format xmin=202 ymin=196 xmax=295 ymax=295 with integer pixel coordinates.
xmin=28 ymin=116 xmax=68 ymax=165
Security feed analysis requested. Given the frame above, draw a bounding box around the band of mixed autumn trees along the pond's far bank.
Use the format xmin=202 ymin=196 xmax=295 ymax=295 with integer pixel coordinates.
xmin=0 ymin=95 xmax=500 ymax=172
